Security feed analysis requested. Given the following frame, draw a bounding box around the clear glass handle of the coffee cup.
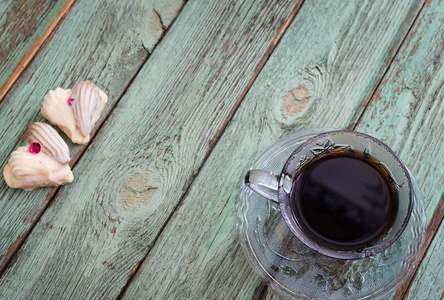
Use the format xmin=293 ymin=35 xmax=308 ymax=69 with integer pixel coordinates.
xmin=244 ymin=169 xmax=279 ymax=204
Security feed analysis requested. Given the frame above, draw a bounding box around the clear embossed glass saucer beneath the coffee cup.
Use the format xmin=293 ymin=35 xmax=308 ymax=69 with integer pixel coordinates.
xmin=236 ymin=128 xmax=425 ymax=299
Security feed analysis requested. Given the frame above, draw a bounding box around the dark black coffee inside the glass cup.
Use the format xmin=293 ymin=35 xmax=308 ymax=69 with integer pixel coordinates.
xmin=291 ymin=152 xmax=398 ymax=250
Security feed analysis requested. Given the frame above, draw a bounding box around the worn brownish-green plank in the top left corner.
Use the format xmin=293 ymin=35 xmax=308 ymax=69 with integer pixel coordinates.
xmin=0 ymin=0 xmax=70 ymax=100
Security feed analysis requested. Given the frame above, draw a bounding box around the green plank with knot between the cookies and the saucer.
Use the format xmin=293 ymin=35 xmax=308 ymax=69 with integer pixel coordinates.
xmin=0 ymin=0 xmax=304 ymax=299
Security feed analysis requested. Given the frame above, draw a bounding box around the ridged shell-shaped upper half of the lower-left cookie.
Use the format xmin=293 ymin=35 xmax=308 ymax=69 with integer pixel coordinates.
xmin=25 ymin=122 xmax=70 ymax=164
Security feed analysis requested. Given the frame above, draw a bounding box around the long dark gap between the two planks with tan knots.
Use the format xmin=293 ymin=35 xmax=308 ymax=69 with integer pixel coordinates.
xmin=116 ymin=0 xmax=305 ymax=300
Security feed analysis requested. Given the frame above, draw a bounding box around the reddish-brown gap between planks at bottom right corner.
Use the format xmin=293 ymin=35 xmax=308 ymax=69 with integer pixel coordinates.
xmin=393 ymin=193 xmax=444 ymax=300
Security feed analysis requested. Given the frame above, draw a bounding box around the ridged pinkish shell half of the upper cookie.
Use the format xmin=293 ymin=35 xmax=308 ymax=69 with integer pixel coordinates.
xmin=71 ymin=81 xmax=105 ymax=136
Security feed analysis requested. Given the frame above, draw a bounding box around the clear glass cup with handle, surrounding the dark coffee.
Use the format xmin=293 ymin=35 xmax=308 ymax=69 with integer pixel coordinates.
xmin=245 ymin=130 xmax=413 ymax=259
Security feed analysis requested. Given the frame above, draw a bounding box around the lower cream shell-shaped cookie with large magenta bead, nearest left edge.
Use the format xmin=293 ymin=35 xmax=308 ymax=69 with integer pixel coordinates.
xmin=3 ymin=122 xmax=74 ymax=191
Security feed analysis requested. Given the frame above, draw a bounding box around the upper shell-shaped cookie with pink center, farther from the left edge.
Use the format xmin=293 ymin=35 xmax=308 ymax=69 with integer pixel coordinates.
xmin=41 ymin=81 xmax=108 ymax=144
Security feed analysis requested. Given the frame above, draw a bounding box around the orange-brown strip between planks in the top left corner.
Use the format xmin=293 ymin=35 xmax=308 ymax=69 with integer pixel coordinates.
xmin=0 ymin=0 xmax=76 ymax=102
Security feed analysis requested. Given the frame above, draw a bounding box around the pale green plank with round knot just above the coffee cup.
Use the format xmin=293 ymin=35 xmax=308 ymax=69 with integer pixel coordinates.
xmin=119 ymin=1 xmax=421 ymax=299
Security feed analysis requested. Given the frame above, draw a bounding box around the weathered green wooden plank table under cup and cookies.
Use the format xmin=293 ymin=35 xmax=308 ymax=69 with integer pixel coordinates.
xmin=0 ymin=0 xmax=444 ymax=299
